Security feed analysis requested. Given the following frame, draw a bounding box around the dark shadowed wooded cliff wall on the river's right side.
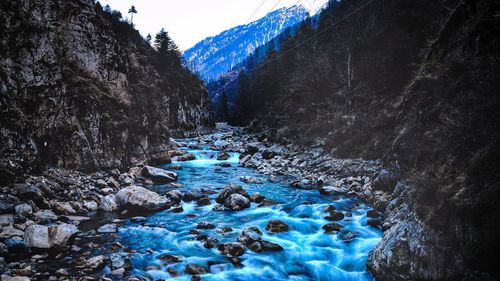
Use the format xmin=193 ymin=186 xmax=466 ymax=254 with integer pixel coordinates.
xmin=234 ymin=0 xmax=500 ymax=280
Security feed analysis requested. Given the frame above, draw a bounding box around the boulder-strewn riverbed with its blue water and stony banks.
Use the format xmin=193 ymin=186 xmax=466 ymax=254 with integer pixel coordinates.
xmin=0 ymin=125 xmax=389 ymax=280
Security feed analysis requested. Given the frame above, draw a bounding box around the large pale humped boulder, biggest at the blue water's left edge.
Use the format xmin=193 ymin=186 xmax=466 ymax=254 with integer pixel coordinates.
xmin=116 ymin=186 xmax=172 ymax=211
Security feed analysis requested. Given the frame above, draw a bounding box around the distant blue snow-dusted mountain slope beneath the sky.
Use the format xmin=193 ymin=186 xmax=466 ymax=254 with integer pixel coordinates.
xmin=183 ymin=5 xmax=312 ymax=81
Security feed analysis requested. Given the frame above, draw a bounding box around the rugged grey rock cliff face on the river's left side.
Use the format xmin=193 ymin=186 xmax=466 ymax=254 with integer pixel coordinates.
xmin=0 ymin=0 xmax=213 ymax=178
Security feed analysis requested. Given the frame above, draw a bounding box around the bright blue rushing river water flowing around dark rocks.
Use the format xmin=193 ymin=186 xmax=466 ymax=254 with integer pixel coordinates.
xmin=110 ymin=143 xmax=382 ymax=281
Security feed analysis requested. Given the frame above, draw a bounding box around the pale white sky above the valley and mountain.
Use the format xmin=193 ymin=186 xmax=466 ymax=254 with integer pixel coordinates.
xmin=99 ymin=0 xmax=316 ymax=51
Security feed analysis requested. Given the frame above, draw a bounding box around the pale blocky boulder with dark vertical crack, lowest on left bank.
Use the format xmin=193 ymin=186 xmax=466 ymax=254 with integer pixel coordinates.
xmin=24 ymin=223 xmax=78 ymax=249
